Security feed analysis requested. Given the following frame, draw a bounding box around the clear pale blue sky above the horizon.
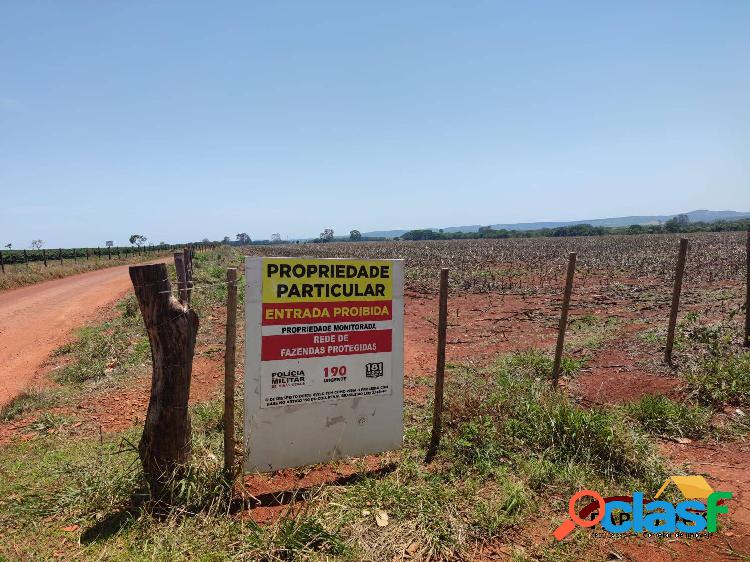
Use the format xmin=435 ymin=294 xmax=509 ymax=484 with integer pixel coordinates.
xmin=0 ymin=0 xmax=750 ymax=248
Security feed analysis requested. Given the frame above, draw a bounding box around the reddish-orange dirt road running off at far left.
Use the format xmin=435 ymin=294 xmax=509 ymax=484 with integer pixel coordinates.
xmin=0 ymin=265 xmax=151 ymax=406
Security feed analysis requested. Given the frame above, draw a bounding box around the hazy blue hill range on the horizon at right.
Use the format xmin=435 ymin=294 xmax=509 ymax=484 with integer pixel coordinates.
xmin=362 ymin=209 xmax=750 ymax=238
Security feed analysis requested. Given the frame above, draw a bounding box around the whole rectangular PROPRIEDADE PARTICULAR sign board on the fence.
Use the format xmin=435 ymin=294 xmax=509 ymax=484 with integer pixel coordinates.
xmin=245 ymin=257 xmax=404 ymax=472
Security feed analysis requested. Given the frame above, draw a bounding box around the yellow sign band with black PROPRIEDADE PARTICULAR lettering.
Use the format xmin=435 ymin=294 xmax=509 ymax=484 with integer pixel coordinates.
xmin=266 ymin=262 xmax=390 ymax=299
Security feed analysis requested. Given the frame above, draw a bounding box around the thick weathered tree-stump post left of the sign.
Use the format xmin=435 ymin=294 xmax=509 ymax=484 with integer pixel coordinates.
xmin=130 ymin=263 xmax=198 ymax=490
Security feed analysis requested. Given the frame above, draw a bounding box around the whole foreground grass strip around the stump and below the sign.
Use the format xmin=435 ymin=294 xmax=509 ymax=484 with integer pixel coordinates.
xmin=0 ymin=351 xmax=676 ymax=562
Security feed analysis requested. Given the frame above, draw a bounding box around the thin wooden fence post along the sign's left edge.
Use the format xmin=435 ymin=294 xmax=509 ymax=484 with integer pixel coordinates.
xmin=224 ymin=267 xmax=237 ymax=476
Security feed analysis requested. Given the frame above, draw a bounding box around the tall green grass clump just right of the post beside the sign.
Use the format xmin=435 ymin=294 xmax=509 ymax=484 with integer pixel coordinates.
xmin=448 ymin=352 xmax=663 ymax=492
